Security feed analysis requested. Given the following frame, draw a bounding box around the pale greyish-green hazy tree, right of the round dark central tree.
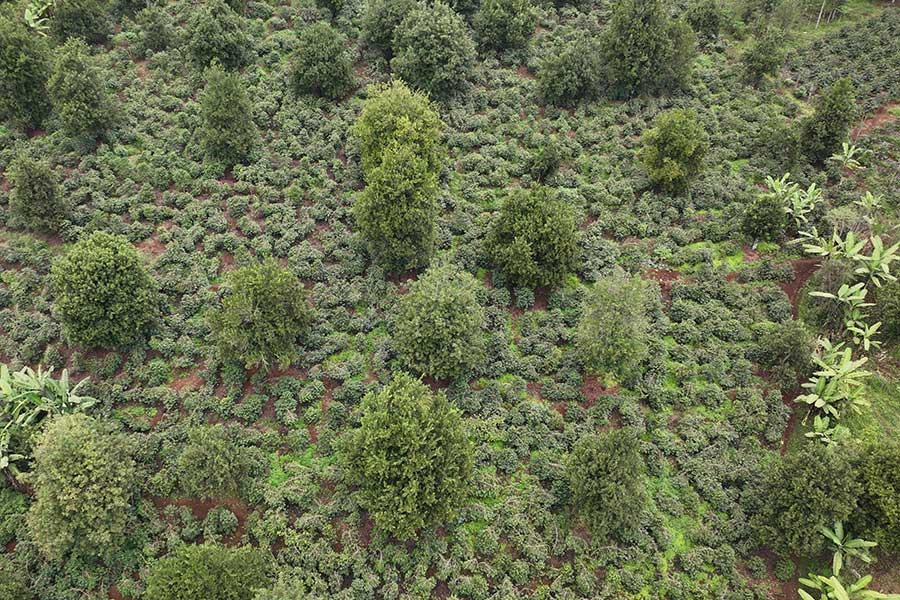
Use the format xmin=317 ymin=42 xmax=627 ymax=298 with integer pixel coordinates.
xmin=575 ymin=271 xmax=650 ymax=381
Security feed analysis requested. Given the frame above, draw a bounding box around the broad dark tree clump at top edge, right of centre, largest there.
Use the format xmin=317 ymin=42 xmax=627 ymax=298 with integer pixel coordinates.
xmin=602 ymin=0 xmax=696 ymax=98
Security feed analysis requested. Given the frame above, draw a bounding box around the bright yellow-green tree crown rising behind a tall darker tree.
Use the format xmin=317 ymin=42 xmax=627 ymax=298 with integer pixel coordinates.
xmin=353 ymin=80 xmax=446 ymax=176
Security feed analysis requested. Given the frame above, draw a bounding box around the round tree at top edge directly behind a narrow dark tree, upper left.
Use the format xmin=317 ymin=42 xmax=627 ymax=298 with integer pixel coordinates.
xmin=187 ymin=0 xmax=252 ymax=69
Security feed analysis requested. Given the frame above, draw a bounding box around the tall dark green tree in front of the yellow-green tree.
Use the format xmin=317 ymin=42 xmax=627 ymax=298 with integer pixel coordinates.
xmin=353 ymin=131 xmax=438 ymax=271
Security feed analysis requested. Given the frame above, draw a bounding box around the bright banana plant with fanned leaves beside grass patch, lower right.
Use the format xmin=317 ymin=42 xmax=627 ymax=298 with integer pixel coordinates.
xmin=795 ymin=339 xmax=871 ymax=420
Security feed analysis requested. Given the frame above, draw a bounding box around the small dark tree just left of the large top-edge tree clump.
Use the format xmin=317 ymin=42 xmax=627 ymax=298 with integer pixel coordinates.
xmin=537 ymin=37 xmax=602 ymax=106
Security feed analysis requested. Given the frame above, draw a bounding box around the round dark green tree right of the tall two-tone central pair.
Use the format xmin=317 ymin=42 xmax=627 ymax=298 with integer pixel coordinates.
xmin=484 ymin=186 xmax=578 ymax=287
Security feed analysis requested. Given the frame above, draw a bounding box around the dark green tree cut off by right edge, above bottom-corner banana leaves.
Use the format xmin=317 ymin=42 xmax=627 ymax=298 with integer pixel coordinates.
xmin=853 ymin=439 xmax=900 ymax=554
